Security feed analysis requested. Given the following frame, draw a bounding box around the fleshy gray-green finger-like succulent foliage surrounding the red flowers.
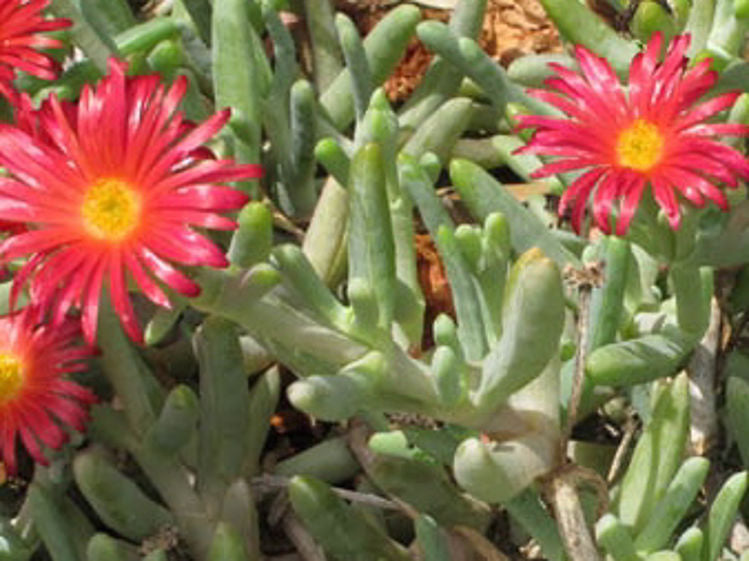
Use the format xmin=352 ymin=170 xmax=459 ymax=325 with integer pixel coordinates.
xmin=5 ymin=0 xmax=749 ymax=561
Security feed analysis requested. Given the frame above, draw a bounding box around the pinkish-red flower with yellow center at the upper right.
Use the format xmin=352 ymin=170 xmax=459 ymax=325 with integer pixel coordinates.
xmin=518 ymin=33 xmax=749 ymax=235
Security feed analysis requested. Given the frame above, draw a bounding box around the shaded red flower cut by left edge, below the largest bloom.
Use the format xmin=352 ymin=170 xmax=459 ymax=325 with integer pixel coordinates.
xmin=0 ymin=307 xmax=96 ymax=474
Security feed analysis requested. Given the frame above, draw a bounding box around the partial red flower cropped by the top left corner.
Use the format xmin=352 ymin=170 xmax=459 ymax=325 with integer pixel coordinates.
xmin=0 ymin=0 xmax=70 ymax=99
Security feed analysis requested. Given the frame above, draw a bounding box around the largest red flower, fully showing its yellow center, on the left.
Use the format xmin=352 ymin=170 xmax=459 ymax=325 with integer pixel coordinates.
xmin=0 ymin=61 xmax=261 ymax=342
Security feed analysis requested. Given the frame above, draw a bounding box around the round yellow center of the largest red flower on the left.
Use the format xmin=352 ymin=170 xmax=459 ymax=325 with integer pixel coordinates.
xmin=81 ymin=177 xmax=140 ymax=242
